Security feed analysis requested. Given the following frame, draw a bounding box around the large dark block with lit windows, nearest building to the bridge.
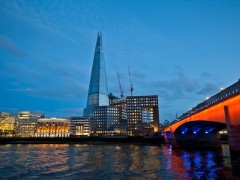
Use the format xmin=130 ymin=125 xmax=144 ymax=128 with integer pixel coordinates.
xmin=127 ymin=95 xmax=159 ymax=136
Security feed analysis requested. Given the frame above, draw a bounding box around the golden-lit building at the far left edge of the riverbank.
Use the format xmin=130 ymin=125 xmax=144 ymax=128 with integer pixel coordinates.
xmin=0 ymin=112 xmax=16 ymax=136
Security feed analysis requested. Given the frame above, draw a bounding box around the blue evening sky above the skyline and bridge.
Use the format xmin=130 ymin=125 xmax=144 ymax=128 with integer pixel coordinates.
xmin=0 ymin=0 xmax=240 ymax=122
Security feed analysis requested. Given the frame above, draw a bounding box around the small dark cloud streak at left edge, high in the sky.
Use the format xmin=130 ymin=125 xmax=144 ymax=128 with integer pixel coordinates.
xmin=0 ymin=36 xmax=27 ymax=57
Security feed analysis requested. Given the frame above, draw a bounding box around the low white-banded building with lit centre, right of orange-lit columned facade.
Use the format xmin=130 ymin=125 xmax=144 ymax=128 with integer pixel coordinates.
xmin=70 ymin=117 xmax=90 ymax=136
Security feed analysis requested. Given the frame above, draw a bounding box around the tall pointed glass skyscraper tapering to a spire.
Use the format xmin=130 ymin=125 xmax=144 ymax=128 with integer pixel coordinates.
xmin=83 ymin=32 xmax=109 ymax=117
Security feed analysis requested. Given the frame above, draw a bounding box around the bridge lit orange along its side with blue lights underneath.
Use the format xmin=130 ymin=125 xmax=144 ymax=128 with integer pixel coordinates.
xmin=164 ymin=79 xmax=240 ymax=176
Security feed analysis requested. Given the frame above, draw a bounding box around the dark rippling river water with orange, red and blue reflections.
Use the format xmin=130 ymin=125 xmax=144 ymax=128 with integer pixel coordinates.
xmin=0 ymin=143 xmax=233 ymax=179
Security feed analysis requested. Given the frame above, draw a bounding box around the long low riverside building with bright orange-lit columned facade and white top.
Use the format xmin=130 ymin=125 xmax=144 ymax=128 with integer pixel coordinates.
xmin=36 ymin=118 xmax=70 ymax=137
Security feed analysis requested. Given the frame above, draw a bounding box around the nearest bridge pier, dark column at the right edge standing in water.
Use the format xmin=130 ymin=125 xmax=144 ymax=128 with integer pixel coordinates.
xmin=224 ymin=106 xmax=240 ymax=179
